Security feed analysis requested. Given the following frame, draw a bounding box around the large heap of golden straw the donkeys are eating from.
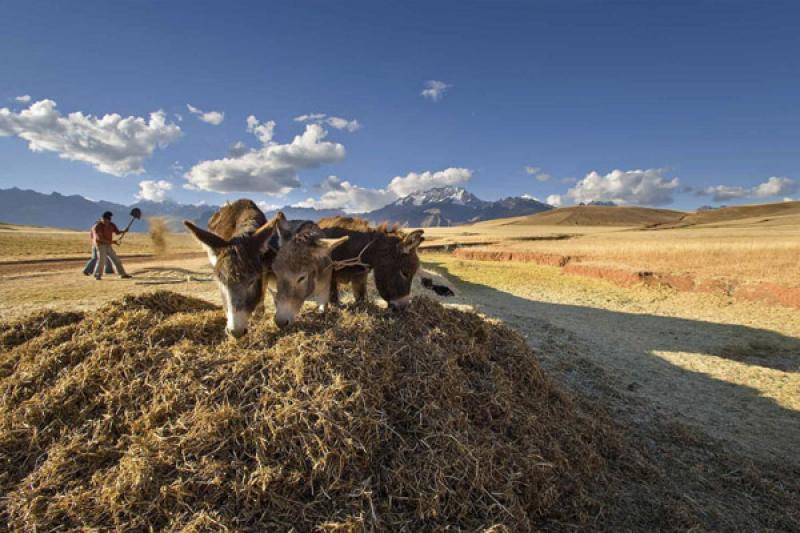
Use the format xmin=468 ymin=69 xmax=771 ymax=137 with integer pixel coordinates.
xmin=0 ymin=292 xmax=617 ymax=531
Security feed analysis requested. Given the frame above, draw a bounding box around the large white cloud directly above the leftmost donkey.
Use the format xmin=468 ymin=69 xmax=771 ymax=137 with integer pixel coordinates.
xmin=184 ymin=115 xmax=345 ymax=195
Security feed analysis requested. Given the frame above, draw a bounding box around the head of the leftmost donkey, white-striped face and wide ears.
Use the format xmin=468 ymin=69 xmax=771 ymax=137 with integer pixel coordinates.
xmin=184 ymin=213 xmax=284 ymax=338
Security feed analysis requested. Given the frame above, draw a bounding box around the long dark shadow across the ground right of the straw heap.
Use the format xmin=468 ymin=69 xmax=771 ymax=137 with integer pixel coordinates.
xmin=422 ymin=263 xmax=800 ymax=463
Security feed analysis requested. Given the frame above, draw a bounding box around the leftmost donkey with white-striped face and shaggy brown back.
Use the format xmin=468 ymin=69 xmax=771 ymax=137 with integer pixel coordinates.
xmin=184 ymin=200 xmax=287 ymax=338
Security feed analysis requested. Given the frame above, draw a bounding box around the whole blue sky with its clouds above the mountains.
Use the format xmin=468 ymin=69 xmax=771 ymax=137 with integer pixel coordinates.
xmin=0 ymin=0 xmax=800 ymax=210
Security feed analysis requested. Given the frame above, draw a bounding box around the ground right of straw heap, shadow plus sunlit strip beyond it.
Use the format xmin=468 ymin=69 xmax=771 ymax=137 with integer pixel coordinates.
xmin=422 ymin=261 xmax=800 ymax=463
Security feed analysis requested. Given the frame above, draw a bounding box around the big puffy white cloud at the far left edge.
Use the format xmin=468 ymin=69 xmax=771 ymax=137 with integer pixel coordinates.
xmin=0 ymin=100 xmax=181 ymax=176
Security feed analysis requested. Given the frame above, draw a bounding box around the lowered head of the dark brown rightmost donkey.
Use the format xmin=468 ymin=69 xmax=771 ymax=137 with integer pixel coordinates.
xmin=373 ymin=229 xmax=424 ymax=310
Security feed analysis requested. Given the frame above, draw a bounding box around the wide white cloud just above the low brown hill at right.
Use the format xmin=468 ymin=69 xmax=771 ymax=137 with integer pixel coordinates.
xmin=566 ymin=168 xmax=680 ymax=205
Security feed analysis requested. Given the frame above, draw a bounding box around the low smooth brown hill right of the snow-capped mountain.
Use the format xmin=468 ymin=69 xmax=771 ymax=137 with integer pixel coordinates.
xmin=509 ymin=205 xmax=686 ymax=226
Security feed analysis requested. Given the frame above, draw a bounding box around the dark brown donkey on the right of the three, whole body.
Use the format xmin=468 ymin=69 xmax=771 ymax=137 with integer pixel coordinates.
xmin=319 ymin=217 xmax=423 ymax=309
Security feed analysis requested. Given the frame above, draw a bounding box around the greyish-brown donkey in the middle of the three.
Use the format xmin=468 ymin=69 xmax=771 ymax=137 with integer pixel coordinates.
xmin=272 ymin=220 xmax=349 ymax=328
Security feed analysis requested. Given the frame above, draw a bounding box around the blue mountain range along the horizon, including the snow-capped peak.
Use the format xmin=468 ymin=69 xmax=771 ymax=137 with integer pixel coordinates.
xmin=0 ymin=187 xmax=552 ymax=231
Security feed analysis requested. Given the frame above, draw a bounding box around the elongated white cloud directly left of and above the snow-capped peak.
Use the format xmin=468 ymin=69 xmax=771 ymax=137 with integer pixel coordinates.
xmin=295 ymin=168 xmax=472 ymax=213
